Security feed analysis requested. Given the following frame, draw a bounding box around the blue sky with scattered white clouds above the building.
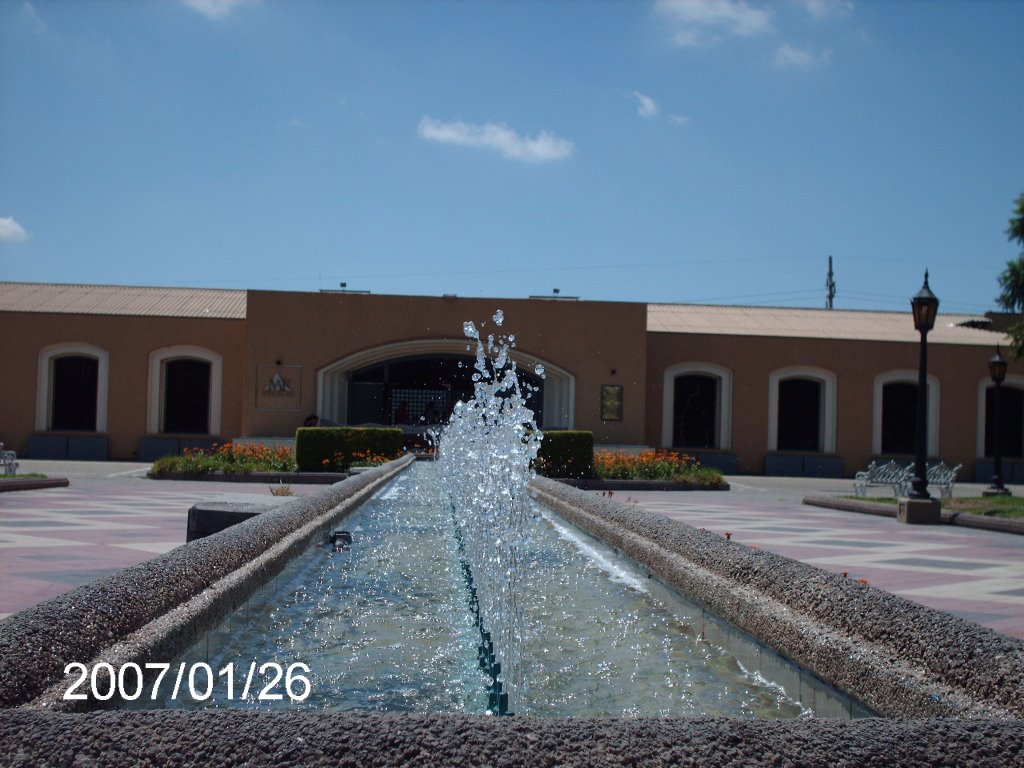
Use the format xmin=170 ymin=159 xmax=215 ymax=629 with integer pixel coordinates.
xmin=0 ymin=0 xmax=1024 ymax=312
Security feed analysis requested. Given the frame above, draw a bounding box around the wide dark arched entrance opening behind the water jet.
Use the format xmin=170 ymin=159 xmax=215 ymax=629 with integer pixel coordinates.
xmin=317 ymin=340 xmax=574 ymax=429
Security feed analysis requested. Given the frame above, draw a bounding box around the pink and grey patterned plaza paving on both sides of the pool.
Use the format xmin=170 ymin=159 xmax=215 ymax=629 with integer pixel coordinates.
xmin=0 ymin=460 xmax=1024 ymax=638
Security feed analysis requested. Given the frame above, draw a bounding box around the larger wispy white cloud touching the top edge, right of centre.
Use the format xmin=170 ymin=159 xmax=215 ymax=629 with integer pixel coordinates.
xmin=654 ymin=0 xmax=772 ymax=46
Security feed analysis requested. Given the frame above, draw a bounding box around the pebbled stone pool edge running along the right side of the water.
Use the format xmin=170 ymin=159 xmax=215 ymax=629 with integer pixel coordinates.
xmin=531 ymin=478 xmax=1024 ymax=719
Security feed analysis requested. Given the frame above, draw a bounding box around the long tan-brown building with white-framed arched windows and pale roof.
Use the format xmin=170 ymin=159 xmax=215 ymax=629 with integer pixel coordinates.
xmin=0 ymin=283 xmax=1024 ymax=482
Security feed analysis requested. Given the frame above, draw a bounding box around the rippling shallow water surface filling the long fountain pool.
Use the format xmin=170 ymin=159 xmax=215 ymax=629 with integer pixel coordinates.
xmin=133 ymin=462 xmax=871 ymax=718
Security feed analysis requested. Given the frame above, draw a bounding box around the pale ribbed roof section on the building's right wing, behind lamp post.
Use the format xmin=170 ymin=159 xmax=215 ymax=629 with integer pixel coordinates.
xmin=647 ymin=302 xmax=1006 ymax=346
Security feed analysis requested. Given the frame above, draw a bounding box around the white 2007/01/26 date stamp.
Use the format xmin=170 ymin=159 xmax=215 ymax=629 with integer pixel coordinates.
xmin=63 ymin=662 xmax=312 ymax=701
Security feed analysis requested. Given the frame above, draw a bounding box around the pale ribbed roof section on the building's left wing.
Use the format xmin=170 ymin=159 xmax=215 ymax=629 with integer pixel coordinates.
xmin=0 ymin=283 xmax=246 ymax=319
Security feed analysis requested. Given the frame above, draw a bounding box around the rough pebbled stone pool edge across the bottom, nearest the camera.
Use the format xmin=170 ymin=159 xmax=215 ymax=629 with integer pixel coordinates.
xmin=0 ymin=710 xmax=1024 ymax=768
